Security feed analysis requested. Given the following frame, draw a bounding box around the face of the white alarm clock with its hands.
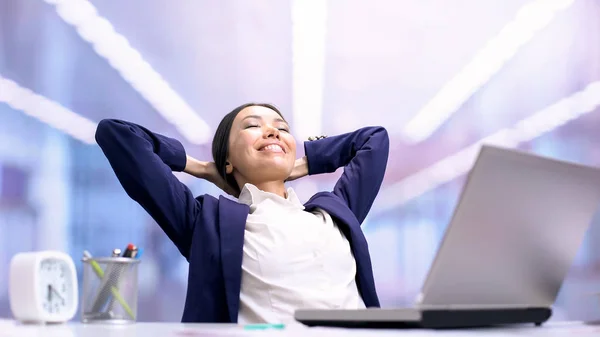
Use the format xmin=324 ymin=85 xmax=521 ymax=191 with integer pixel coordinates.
xmin=37 ymin=258 xmax=74 ymax=315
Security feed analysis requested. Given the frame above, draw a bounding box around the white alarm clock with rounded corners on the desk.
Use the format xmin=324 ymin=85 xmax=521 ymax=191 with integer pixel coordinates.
xmin=8 ymin=251 xmax=78 ymax=323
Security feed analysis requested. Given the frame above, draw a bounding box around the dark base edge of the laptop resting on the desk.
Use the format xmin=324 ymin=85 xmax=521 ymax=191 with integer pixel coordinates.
xmin=298 ymin=308 xmax=552 ymax=329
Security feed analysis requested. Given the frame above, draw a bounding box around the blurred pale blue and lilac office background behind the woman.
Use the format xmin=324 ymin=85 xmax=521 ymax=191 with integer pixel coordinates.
xmin=0 ymin=0 xmax=600 ymax=321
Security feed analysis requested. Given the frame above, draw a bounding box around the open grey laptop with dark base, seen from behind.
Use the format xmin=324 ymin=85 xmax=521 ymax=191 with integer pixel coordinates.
xmin=295 ymin=145 xmax=600 ymax=328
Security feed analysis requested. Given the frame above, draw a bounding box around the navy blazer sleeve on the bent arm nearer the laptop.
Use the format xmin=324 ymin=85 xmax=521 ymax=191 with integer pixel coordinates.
xmin=304 ymin=127 xmax=389 ymax=223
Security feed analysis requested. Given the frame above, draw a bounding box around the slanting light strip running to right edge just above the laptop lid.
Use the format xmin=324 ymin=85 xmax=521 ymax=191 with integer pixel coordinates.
xmin=375 ymin=81 xmax=600 ymax=212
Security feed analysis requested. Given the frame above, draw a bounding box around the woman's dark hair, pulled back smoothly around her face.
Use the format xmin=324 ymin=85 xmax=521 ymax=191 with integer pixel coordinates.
xmin=212 ymin=103 xmax=285 ymax=193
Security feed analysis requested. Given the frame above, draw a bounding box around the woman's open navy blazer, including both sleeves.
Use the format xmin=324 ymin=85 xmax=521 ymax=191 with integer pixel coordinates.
xmin=96 ymin=120 xmax=389 ymax=323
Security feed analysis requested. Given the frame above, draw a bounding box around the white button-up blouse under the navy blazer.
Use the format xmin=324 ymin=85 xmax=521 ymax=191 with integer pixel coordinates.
xmin=238 ymin=184 xmax=365 ymax=324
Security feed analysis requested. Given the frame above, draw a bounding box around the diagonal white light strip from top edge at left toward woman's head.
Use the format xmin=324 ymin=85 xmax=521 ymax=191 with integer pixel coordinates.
xmin=44 ymin=0 xmax=212 ymax=144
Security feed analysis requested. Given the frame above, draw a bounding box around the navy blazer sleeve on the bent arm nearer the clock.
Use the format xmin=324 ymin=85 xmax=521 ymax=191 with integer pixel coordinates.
xmin=96 ymin=119 xmax=202 ymax=259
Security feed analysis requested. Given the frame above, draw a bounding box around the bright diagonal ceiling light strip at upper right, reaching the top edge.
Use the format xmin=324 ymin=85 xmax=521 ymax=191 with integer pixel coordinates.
xmin=402 ymin=0 xmax=574 ymax=143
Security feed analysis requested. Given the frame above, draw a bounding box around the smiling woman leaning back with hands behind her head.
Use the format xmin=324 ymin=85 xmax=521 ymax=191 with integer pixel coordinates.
xmin=96 ymin=103 xmax=389 ymax=323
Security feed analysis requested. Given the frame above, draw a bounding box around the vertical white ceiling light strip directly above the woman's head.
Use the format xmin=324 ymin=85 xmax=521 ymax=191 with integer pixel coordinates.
xmin=292 ymin=0 xmax=327 ymax=138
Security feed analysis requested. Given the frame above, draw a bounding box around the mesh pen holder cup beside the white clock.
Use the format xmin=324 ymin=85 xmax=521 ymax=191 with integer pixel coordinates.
xmin=81 ymin=257 xmax=140 ymax=324
